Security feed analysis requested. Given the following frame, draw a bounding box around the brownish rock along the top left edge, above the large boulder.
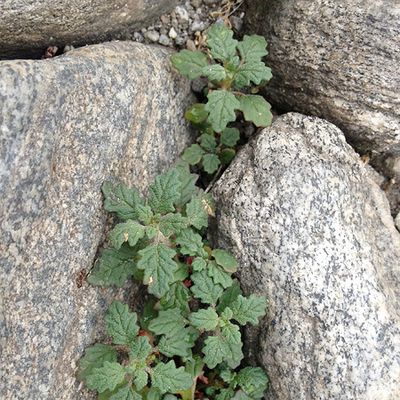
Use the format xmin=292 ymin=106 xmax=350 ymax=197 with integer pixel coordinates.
xmin=0 ymin=0 xmax=178 ymax=58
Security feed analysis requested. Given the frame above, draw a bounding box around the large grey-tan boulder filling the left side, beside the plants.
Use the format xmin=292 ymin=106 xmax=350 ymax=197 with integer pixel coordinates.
xmin=0 ymin=43 xmax=193 ymax=400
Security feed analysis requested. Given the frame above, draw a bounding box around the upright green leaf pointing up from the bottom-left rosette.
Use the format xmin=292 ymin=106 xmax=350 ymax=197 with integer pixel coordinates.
xmin=105 ymin=301 xmax=139 ymax=345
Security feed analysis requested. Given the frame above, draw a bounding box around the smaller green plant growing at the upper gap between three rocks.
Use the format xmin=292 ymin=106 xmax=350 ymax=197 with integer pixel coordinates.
xmin=171 ymin=24 xmax=272 ymax=174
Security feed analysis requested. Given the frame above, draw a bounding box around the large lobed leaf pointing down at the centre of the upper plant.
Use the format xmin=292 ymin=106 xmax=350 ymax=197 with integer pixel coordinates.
xmin=205 ymin=90 xmax=240 ymax=132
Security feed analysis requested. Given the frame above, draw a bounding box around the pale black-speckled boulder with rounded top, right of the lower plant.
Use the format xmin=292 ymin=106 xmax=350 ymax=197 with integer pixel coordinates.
xmin=214 ymin=113 xmax=400 ymax=400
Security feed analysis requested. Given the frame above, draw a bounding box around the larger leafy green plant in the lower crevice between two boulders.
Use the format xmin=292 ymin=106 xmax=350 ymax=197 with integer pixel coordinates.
xmin=79 ymin=162 xmax=268 ymax=400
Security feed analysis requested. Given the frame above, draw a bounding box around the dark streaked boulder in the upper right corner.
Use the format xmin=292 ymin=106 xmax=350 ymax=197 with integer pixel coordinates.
xmin=247 ymin=0 xmax=400 ymax=159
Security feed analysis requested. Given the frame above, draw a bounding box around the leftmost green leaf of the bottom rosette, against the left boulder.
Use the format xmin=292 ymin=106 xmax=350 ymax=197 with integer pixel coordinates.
xmin=78 ymin=343 xmax=117 ymax=380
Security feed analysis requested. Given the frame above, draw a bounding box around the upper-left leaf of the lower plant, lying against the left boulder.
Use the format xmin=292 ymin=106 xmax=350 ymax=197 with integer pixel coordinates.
xmin=101 ymin=182 xmax=143 ymax=220
